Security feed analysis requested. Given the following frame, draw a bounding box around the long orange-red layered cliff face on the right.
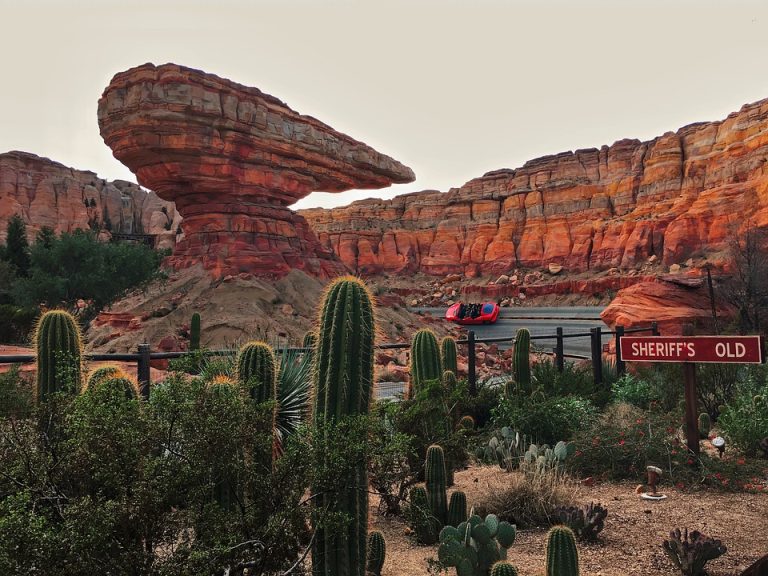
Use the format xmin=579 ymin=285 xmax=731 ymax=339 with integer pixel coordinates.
xmin=300 ymin=100 xmax=768 ymax=276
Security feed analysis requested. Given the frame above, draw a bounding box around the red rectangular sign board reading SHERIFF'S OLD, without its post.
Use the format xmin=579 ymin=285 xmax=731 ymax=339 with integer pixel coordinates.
xmin=620 ymin=336 xmax=764 ymax=364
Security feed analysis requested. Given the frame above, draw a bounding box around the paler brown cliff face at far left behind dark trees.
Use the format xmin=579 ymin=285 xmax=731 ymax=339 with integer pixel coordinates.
xmin=0 ymin=152 xmax=181 ymax=246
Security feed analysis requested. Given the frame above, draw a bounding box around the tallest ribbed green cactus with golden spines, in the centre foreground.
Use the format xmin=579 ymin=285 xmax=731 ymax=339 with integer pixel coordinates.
xmin=312 ymin=277 xmax=376 ymax=576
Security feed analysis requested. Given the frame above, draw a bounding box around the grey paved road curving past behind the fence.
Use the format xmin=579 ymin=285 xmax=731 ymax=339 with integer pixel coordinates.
xmin=410 ymin=306 xmax=612 ymax=356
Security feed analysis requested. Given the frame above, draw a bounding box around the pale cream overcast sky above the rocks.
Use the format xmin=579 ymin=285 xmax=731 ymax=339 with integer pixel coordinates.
xmin=0 ymin=0 xmax=768 ymax=208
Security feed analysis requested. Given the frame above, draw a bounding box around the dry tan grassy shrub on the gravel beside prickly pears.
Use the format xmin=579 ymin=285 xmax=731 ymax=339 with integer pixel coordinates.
xmin=473 ymin=466 xmax=577 ymax=528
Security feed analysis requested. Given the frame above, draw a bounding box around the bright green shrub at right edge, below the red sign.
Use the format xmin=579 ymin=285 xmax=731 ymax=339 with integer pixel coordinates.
xmin=718 ymin=377 xmax=768 ymax=456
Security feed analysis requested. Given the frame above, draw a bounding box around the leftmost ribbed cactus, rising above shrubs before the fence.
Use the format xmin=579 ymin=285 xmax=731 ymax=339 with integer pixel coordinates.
xmin=35 ymin=310 xmax=83 ymax=401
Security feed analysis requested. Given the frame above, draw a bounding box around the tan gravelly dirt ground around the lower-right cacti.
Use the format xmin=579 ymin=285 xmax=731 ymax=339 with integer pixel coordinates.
xmin=371 ymin=466 xmax=768 ymax=576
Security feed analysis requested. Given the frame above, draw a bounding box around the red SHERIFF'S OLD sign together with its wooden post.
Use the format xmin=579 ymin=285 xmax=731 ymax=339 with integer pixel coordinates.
xmin=619 ymin=326 xmax=765 ymax=456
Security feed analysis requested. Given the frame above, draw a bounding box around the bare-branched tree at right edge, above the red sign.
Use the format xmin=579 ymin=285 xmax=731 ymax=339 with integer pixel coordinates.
xmin=720 ymin=223 xmax=768 ymax=334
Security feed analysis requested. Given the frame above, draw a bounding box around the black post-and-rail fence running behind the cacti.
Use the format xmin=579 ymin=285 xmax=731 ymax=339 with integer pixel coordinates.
xmin=0 ymin=322 xmax=659 ymax=397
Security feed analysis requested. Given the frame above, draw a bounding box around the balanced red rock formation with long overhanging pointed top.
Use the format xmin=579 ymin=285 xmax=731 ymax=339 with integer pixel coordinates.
xmin=99 ymin=64 xmax=414 ymax=277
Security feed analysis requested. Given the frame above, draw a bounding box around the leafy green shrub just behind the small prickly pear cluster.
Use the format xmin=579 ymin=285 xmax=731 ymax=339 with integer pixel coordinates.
xmin=492 ymin=395 xmax=597 ymax=445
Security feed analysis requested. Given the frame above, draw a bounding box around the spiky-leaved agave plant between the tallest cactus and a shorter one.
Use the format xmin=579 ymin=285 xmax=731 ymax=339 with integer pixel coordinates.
xmin=277 ymin=349 xmax=312 ymax=441
